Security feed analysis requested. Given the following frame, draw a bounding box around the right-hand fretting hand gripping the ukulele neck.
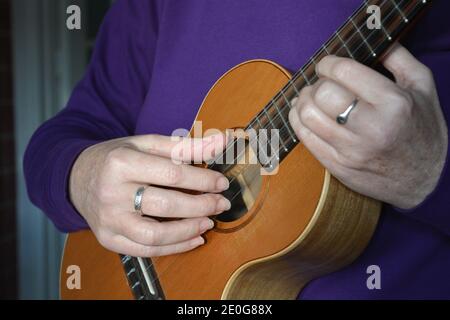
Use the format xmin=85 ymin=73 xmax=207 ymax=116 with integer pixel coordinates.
xmin=289 ymin=45 xmax=448 ymax=209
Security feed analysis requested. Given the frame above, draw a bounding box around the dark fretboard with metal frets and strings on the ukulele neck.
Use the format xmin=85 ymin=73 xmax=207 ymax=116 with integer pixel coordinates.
xmin=247 ymin=0 xmax=432 ymax=168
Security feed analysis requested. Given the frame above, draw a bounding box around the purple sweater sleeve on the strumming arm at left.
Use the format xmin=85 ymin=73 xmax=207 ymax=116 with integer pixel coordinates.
xmin=23 ymin=0 xmax=158 ymax=232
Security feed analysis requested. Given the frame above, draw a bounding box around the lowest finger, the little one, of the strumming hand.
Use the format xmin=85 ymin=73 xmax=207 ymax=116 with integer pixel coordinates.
xmin=108 ymin=235 xmax=205 ymax=258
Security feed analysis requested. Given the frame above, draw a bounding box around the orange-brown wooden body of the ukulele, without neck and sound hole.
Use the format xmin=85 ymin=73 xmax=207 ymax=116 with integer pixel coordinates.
xmin=60 ymin=60 xmax=381 ymax=299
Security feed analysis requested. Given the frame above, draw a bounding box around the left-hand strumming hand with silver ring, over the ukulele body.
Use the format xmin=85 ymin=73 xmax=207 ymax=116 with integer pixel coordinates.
xmin=70 ymin=135 xmax=230 ymax=257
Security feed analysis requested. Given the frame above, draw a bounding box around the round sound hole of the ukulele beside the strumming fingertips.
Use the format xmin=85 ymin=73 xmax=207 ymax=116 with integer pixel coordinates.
xmin=210 ymin=140 xmax=262 ymax=222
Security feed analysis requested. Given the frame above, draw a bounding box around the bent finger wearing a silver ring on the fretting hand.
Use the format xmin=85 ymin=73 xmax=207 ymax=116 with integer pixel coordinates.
xmin=311 ymin=78 xmax=377 ymax=133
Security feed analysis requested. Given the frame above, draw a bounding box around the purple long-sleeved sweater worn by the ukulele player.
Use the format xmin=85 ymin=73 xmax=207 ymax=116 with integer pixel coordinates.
xmin=24 ymin=0 xmax=450 ymax=299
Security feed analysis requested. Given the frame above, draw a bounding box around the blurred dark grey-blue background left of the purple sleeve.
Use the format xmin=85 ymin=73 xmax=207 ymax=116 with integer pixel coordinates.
xmin=0 ymin=0 xmax=113 ymax=299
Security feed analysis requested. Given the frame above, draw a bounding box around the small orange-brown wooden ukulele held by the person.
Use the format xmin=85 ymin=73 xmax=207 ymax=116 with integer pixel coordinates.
xmin=60 ymin=0 xmax=431 ymax=300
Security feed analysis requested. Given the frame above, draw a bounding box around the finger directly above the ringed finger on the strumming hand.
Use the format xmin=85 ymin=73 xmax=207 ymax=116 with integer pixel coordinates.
xmin=125 ymin=150 xmax=229 ymax=192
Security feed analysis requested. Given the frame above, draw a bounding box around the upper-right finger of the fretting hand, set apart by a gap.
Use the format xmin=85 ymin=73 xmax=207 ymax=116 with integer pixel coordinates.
xmin=383 ymin=43 xmax=434 ymax=92
